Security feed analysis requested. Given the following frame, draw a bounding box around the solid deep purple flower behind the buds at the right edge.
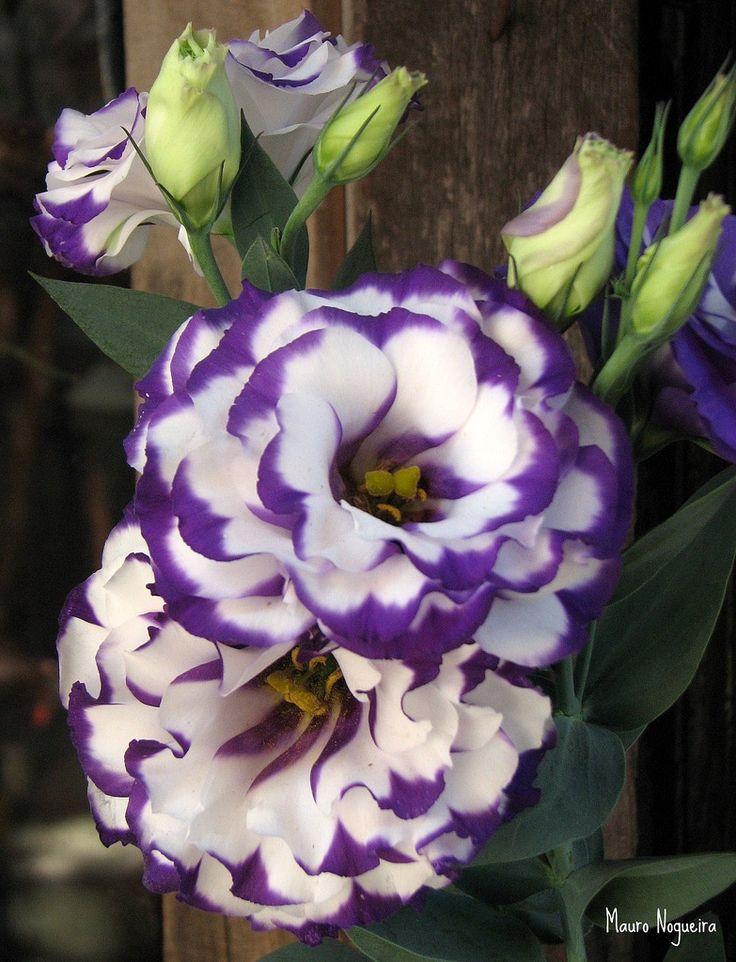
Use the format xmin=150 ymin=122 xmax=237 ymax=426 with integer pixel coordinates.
xmin=600 ymin=191 xmax=736 ymax=461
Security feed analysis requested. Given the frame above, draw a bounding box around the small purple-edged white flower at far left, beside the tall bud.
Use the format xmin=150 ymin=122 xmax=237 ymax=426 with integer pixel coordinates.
xmin=31 ymin=87 xmax=186 ymax=276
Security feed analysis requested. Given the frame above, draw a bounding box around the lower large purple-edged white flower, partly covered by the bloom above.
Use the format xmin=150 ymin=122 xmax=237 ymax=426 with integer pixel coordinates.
xmin=59 ymin=516 xmax=553 ymax=943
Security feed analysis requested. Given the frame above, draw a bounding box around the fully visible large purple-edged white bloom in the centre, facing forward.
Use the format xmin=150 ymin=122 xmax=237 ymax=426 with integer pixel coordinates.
xmin=129 ymin=264 xmax=631 ymax=666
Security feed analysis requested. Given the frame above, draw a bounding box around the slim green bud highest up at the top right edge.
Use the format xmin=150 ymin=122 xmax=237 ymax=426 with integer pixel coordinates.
xmin=677 ymin=66 xmax=736 ymax=170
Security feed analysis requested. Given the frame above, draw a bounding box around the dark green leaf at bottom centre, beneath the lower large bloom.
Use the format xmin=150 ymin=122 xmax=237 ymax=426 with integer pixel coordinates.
xmin=347 ymin=892 xmax=544 ymax=962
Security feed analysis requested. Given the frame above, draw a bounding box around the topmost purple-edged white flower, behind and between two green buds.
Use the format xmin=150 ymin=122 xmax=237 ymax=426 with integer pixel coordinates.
xmin=226 ymin=10 xmax=387 ymax=196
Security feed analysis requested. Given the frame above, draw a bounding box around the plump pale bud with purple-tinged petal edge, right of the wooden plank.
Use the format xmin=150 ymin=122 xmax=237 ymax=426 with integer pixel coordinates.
xmin=501 ymin=134 xmax=631 ymax=317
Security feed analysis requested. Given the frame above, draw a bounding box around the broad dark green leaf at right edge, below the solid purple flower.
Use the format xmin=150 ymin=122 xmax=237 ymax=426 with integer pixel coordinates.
xmin=583 ymin=468 xmax=736 ymax=732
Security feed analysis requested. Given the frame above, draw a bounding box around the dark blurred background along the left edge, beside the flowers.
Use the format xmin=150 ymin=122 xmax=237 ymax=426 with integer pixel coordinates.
xmin=0 ymin=0 xmax=161 ymax=962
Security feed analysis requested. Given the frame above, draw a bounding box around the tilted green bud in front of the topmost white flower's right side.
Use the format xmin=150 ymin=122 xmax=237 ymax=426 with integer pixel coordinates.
xmin=313 ymin=67 xmax=427 ymax=184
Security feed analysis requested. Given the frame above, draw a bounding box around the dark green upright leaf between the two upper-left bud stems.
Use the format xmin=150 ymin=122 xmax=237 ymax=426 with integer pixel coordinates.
xmin=230 ymin=115 xmax=309 ymax=282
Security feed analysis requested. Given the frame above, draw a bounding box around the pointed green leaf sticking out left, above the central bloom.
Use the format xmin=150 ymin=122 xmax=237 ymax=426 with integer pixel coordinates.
xmin=31 ymin=274 xmax=201 ymax=378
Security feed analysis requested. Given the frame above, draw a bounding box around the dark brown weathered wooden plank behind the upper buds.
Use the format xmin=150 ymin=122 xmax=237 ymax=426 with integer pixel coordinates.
xmin=344 ymin=0 xmax=637 ymax=269
